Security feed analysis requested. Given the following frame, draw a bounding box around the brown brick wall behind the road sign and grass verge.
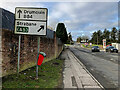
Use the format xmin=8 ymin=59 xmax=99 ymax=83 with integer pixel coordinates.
xmin=1 ymin=30 xmax=63 ymax=76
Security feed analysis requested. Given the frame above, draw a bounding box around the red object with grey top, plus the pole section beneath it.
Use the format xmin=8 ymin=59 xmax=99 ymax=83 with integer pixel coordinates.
xmin=36 ymin=52 xmax=46 ymax=79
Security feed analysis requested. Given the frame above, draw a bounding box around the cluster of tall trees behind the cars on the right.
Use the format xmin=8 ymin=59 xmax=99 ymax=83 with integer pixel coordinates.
xmin=89 ymin=27 xmax=120 ymax=44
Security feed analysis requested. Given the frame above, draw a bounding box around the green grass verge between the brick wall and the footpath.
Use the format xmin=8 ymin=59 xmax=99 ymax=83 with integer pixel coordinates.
xmin=2 ymin=59 xmax=64 ymax=89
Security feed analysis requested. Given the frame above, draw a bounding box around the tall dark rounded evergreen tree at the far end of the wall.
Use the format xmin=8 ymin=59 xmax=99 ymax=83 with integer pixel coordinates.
xmin=56 ymin=23 xmax=68 ymax=43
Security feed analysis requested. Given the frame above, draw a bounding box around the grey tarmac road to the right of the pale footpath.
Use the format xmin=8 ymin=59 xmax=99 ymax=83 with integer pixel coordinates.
xmin=69 ymin=46 xmax=119 ymax=88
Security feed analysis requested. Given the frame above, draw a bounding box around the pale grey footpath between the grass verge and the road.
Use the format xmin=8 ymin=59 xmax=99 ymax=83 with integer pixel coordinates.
xmin=63 ymin=49 xmax=104 ymax=90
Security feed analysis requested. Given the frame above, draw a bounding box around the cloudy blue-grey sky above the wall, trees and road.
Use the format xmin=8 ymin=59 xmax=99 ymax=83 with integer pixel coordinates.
xmin=0 ymin=0 xmax=118 ymax=40
